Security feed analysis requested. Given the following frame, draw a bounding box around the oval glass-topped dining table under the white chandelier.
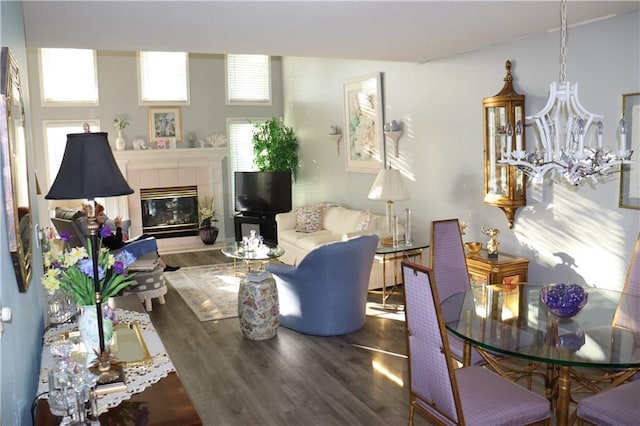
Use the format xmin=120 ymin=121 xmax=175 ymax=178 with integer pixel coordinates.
xmin=441 ymin=283 xmax=640 ymax=426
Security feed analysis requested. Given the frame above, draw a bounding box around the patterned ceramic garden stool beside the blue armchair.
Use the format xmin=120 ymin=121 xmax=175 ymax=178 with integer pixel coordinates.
xmin=238 ymin=272 xmax=280 ymax=340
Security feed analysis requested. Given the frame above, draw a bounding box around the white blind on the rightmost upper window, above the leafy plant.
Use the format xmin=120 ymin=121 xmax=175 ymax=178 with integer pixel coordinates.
xmin=225 ymin=55 xmax=271 ymax=105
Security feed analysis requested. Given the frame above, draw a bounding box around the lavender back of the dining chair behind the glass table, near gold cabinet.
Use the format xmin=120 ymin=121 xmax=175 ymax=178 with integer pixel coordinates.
xmin=431 ymin=219 xmax=471 ymax=300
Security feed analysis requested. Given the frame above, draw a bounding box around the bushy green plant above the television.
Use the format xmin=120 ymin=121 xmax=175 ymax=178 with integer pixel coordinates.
xmin=252 ymin=117 xmax=298 ymax=178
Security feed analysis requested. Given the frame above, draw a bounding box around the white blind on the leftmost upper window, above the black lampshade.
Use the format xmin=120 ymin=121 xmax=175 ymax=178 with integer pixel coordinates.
xmin=39 ymin=48 xmax=98 ymax=105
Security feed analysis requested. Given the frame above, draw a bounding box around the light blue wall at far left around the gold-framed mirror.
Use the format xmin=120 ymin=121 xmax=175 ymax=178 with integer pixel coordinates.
xmin=0 ymin=1 xmax=46 ymax=426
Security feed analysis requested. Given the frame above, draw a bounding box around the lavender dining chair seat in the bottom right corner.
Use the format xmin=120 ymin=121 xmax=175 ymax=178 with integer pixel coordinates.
xmin=577 ymin=380 xmax=640 ymax=426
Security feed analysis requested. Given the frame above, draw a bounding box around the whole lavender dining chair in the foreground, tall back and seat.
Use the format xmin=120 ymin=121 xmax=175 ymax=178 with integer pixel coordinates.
xmin=402 ymin=261 xmax=551 ymax=425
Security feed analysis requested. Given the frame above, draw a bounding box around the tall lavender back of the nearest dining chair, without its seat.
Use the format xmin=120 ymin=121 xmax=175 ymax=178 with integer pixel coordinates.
xmin=402 ymin=262 xmax=464 ymax=424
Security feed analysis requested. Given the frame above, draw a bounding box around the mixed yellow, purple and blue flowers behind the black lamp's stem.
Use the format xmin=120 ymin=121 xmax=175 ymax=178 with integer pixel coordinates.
xmin=42 ymin=230 xmax=136 ymax=306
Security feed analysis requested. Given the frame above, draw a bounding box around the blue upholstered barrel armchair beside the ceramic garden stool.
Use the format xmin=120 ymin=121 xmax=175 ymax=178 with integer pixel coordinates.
xmin=267 ymin=235 xmax=378 ymax=336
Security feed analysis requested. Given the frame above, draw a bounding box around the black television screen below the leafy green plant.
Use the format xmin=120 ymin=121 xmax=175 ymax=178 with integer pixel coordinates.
xmin=234 ymin=172 xmax=291 ymax=215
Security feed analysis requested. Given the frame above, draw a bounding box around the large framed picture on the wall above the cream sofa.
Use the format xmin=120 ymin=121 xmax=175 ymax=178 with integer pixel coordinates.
xmin=344 ymin=73 xmax=384 ymax=173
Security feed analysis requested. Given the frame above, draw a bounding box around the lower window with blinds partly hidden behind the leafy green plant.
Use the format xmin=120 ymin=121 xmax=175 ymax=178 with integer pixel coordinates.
xmin=227 ymin=118 xmax=266 ymax=213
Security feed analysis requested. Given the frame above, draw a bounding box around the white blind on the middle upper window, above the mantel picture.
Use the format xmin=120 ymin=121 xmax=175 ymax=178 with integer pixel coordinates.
xmin=138 ymin=52 xmax=189 ymax=104
